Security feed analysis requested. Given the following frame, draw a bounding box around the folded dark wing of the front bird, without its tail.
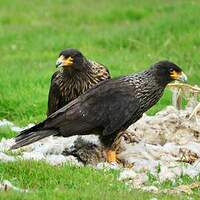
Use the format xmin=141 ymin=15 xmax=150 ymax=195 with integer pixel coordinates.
xmin=45 ymin=80 xmax=139 ymax=136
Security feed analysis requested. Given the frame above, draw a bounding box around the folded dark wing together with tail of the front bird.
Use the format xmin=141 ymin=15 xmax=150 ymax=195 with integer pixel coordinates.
xmin=12 ymin=79 xmax=140 ymax=148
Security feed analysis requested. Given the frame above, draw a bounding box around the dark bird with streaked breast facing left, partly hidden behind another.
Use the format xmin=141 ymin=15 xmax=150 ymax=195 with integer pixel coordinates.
xmin=47 ymin=48 xmax=111 ymax=116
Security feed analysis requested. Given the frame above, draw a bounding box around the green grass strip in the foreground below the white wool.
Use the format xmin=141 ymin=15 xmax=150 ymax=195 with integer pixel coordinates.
xmin=0 ymin=161 xmax=198 ymax=200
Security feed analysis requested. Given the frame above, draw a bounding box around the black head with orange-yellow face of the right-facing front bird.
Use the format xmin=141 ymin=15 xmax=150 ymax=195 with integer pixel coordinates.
xmin=152 ymin=61 xmax=187 ymax=84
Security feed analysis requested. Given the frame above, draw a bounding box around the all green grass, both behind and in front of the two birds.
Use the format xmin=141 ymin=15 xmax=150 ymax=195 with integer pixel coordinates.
xmin=0 ymin=0 xmax=200 ymax=199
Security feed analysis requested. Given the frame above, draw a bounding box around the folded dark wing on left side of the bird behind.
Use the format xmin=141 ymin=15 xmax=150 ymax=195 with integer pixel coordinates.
xmin=47 ymin=71 xmax=62 ymax=116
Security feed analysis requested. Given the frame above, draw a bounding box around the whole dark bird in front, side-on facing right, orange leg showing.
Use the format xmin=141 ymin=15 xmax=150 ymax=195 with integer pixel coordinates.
xmin=11 ymin=60 xmax=187 ymax=162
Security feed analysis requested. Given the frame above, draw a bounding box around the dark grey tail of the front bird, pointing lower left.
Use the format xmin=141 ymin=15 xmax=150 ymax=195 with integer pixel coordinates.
xmin=11 ymin=123 xmax=58 ymax=149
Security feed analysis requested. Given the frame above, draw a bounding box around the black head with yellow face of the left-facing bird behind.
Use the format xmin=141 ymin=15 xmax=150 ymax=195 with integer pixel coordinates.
xmin=56 ymin=49 xmax=84 ymax=69
